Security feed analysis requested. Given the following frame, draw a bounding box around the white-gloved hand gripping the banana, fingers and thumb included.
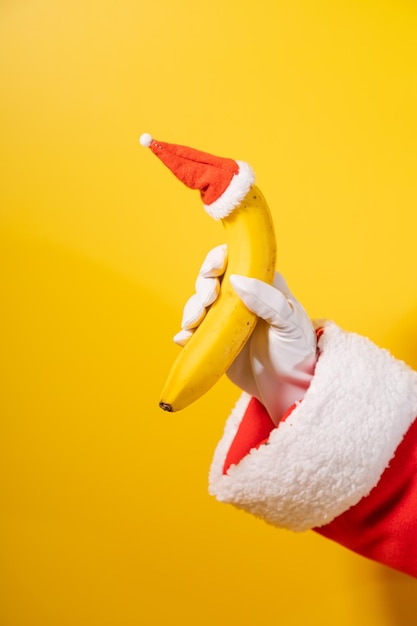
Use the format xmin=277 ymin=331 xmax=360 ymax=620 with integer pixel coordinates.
xmin=174 ymin=245 xmax=317 ymax=424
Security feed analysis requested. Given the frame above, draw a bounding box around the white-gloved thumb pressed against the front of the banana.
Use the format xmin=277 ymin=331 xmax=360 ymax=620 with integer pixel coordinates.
xmin=230 ymin=274 xmax=294 ymax=328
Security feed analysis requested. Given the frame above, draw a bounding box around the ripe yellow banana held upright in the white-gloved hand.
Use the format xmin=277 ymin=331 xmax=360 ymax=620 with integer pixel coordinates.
xmin=141 ymin=135 xmax=276 ymax=411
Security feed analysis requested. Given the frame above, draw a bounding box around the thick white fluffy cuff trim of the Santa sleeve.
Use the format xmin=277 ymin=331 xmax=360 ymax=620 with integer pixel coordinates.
xmin=209 ymin=323 xmax=417 ymax=531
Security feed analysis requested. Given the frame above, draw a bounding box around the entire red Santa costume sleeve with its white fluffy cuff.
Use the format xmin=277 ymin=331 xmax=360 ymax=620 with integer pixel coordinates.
xmin=209 ymin=323 xmax=417 ymax=577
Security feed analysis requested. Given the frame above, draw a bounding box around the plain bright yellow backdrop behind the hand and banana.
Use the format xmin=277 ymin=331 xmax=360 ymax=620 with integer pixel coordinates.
xmin=0 ymin=0 xmax=417 ymax=626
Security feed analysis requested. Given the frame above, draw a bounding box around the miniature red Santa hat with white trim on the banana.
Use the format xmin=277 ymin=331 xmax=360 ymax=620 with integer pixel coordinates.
xmin=139 ymin=133 xmax=255 ymax=219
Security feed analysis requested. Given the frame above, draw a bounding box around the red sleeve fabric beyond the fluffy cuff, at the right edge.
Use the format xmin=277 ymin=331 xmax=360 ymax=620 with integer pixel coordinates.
xmin=315 ymin=420 xmax=417 ymax=577
